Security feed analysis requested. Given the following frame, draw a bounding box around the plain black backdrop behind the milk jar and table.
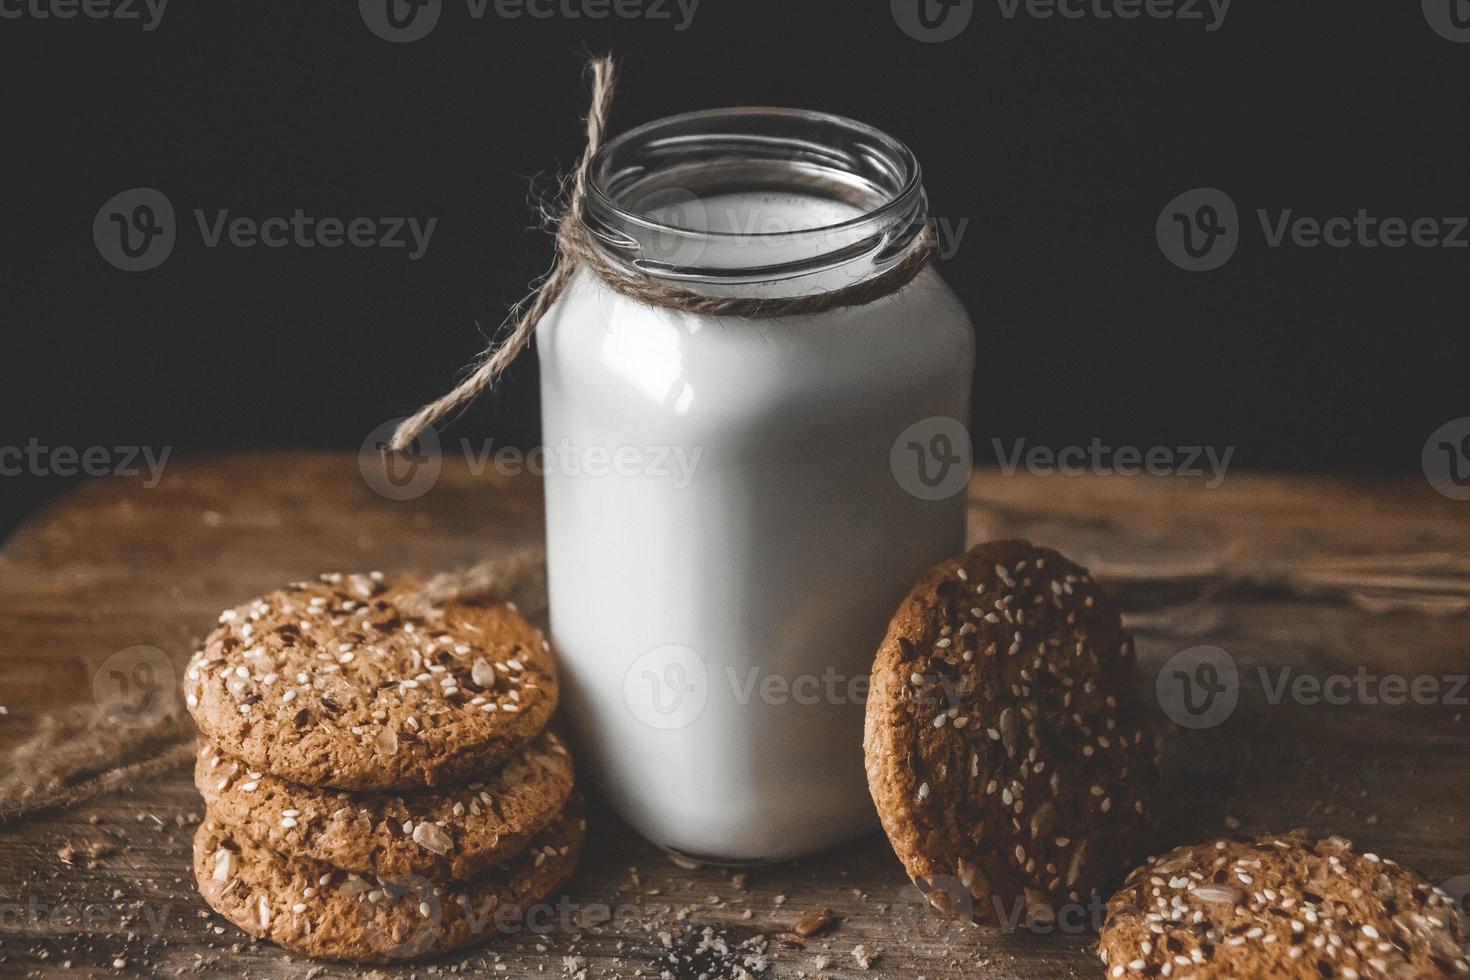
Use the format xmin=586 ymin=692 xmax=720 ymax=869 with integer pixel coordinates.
xmin=0 ymin=0 xmax=1470 ymax=529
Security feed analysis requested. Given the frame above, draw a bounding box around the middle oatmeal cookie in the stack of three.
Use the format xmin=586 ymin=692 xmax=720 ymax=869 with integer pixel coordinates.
xmin=194 ymin=732 xmax=572 ymax=879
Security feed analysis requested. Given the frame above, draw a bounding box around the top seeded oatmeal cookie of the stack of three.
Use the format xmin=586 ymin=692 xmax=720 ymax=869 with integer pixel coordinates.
xmin=184 ymin=573 xmax=557 ymax=790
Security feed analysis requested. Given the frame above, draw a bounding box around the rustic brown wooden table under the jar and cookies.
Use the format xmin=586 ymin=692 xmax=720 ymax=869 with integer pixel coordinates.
xmin=0 ymin=454 xmax=1470 ymax=980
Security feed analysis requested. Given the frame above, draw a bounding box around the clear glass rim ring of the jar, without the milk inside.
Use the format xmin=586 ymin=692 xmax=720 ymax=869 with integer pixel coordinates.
xmin=582 ymin=106 xmax=928 ymax=281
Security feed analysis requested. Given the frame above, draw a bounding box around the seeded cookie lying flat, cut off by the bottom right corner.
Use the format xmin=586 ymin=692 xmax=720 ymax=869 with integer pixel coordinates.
xmin=1098 ymin=830 xmax=1470 ymax=980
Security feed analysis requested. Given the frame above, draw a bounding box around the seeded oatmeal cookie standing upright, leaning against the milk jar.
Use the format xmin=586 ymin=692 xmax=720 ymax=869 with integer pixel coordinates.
xmin=863 ymin=541 xmax=1155 ymax=923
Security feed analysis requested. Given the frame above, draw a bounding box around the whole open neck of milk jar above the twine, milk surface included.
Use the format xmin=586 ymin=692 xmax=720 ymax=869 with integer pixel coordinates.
xmin=584 ymin=109 xmax=929 ymax=295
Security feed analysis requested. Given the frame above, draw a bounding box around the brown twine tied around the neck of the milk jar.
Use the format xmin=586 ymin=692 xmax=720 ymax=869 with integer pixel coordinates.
xmin=387 ymin=56 xmax=938 ymax=453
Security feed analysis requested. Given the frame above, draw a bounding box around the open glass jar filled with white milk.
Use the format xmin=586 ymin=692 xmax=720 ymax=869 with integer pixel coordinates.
xmin=537 ymin=109 xmax=975 ymax=861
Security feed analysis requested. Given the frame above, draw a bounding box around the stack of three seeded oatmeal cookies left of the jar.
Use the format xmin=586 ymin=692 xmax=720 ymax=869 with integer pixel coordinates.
xmin=185 ymin=573 xmax=585 ymax=962
